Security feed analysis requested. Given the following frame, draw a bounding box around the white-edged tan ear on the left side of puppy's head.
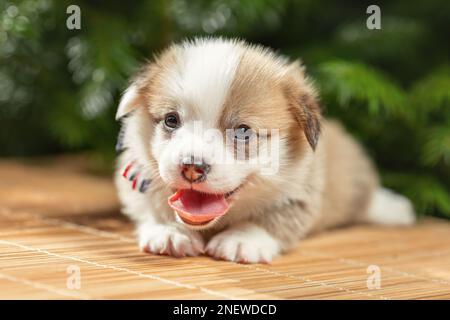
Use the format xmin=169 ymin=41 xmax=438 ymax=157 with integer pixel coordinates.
xmin=116 ymin=64 xmax=155 ymax=120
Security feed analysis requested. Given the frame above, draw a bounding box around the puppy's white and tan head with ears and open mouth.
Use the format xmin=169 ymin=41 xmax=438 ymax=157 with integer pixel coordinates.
xmin=117 ymin=39 xmax=320 ymax=228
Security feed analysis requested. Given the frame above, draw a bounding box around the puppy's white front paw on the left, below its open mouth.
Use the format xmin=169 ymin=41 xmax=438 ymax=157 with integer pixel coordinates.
xmin=138 ymin=224 xmax=204 ymax=257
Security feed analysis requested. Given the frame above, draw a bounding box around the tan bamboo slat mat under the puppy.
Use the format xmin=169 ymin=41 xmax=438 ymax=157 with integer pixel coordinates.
xmin=0 ymin=157 xmax=450 ymax=299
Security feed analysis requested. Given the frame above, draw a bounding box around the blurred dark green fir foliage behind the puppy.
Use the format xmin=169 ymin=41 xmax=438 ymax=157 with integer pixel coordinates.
xmin=0 ymin=0 xmax=450 ymax=218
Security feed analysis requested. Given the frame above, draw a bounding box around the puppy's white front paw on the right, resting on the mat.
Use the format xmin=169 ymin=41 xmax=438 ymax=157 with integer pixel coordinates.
xmin=206 ymin=224 xmax=281 ymax=263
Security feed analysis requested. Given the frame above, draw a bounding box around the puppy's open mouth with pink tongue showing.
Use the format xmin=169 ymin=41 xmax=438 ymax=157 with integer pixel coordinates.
xmin=169 ymin=189 xmax=229 ymax=224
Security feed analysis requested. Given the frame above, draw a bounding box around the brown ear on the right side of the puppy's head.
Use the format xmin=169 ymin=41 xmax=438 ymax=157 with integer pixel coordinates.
xmin=284 ymin=61 xmax=322 ymax=150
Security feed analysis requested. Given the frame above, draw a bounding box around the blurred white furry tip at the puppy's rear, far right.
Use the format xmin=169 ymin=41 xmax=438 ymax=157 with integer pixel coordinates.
xmin=366 ymin=188 xmax=415 ymax=226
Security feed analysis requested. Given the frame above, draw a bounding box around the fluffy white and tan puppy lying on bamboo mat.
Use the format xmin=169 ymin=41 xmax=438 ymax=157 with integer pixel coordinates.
xmin=115 ymin=38 xmax=415 ymax=263
